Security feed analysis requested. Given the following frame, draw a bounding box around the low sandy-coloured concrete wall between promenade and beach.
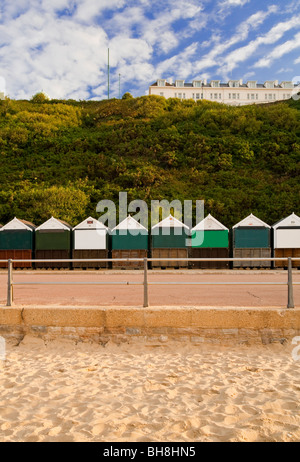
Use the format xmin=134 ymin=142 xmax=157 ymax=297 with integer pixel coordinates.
xmin=0 ymin=307 xmax=300 ymax=345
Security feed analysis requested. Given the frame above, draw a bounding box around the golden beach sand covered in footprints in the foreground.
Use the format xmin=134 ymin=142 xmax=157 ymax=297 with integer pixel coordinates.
xmin=0 ymin=336 xmax=300 ymax=442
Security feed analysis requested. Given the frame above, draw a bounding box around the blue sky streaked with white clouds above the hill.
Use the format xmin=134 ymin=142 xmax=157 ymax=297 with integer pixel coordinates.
xmin=0 ymin=0 xmax=300 ymax=100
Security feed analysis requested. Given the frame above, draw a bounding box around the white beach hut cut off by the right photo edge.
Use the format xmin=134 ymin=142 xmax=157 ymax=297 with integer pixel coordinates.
xmin=273 ymin=213 xmax=300 ymax=268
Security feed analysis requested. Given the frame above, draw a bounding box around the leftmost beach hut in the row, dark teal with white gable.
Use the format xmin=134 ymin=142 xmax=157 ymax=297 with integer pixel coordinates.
xmin=0 ymin=217 xmax=35 ymax=268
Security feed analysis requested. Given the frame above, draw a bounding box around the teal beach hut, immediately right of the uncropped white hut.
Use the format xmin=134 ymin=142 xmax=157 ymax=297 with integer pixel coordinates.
xmin=111 ymin=215 xmax=149 ymax=268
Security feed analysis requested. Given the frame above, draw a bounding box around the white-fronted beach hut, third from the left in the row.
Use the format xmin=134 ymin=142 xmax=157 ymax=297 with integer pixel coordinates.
xmin=72 ymin=217 xmax=109 ymax=268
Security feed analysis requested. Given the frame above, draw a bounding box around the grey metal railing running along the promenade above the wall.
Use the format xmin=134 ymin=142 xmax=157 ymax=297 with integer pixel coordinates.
xmin=0 ymin=257 xmax=300 ymax=308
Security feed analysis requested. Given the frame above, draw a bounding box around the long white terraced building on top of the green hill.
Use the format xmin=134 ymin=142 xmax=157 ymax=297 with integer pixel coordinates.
xmin=149 ymin=79 xmax=296 ymax=106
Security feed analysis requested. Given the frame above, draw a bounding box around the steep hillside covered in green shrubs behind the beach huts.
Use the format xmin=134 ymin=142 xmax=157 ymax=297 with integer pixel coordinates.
xmin=0 ymin=95 xmax=300 ymax=227
